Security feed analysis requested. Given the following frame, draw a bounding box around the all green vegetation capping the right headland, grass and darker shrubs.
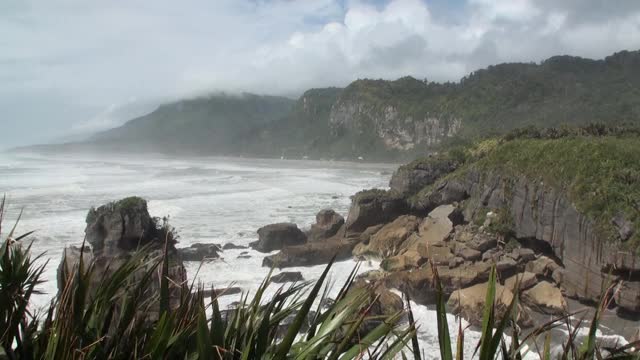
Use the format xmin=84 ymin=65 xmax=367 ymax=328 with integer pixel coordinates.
xmin=406 ymin=124 xmax=640 ymax=249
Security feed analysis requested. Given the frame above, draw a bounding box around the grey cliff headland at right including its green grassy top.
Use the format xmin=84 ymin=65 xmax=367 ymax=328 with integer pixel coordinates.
xmin=400 ymin=138 xmax=640 ymax=312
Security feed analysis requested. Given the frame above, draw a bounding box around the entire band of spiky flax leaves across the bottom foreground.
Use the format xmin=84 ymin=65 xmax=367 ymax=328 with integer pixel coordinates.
xmin=0 ymin=201 xmax=640 ymax=360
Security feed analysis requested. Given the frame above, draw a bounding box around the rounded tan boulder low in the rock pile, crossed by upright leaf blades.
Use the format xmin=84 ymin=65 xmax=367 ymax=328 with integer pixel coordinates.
xmin=447 ymin=283 xmax=533 ymax=327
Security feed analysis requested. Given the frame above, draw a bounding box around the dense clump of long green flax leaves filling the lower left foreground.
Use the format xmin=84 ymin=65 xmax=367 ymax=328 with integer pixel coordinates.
xmin=0 ymin=202 xmax=415 ymax=360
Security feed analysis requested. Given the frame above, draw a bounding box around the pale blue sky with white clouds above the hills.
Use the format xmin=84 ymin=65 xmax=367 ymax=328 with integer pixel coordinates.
xmin=0 ymin=0 xmax=640 ymax=148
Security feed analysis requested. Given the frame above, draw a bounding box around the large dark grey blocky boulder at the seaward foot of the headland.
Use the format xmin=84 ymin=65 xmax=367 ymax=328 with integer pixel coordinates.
xmin=346 ymin=189 xmax=408 ymax=233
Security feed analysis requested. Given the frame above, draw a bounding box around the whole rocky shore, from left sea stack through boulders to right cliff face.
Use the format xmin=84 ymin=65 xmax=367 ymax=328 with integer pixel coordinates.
xmin=58 ymin=149 xmax=640 ymax=340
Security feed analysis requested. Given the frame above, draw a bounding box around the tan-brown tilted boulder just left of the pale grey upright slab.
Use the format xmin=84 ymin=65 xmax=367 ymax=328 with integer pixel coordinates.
xmin=354 ymin=215 xmax=420 ymax=257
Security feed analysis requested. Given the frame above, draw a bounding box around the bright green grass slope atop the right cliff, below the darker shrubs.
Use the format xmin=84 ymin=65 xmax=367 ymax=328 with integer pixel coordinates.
xmin=470 ymin=136 xmax=640 ymax=247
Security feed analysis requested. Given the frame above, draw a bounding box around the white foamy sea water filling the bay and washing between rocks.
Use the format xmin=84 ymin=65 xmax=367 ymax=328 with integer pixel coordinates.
xmin=0 ymin=150 xmax=510 ymax=359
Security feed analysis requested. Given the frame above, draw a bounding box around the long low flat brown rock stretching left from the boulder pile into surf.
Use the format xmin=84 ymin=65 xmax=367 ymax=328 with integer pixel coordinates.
xmin=262 ymin=231 xmax=358 ymax=268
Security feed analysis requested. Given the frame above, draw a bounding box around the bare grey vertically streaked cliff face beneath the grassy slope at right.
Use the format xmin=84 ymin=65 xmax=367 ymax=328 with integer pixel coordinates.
xmin=438 ymin=171 xmax=640 ymax=312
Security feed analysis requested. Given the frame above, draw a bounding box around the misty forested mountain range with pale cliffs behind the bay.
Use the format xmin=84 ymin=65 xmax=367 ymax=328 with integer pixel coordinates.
xmin=82 ymin=51 xmax=640 ymax=159
